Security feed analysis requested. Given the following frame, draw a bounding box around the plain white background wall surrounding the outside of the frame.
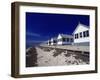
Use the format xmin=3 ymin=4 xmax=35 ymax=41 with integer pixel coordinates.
xmin=0 ymin=0 xmax=100 ymax=80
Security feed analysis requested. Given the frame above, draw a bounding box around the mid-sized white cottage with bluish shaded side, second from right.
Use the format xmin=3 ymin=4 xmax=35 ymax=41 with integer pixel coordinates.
xmin=57 ymin=34 xmax=73 ymax=45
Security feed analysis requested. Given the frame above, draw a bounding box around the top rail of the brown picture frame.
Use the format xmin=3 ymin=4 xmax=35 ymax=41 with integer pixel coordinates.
xmin=14 ymin=1 xmax=97 ymax=10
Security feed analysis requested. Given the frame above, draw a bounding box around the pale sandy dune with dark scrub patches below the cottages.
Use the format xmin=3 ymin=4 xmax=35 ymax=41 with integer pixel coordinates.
xmin=27 ymin=47 xmax=89 ymax=67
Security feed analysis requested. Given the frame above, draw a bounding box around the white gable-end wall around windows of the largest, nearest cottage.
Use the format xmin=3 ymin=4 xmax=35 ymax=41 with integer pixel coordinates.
xmin=74 ymin=25 xmax=89 ymax=43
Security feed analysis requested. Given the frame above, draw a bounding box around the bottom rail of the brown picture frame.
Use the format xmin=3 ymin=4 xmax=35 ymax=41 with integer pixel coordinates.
xmin=15 ymin=70 xmax=97 ymax=78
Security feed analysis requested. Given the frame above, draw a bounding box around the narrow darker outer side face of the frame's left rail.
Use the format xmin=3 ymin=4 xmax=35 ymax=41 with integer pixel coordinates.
xmin=11 ymin=4 xmax=15 ymax=77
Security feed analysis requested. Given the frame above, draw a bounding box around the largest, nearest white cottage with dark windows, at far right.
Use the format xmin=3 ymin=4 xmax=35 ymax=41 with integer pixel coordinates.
xmin=73 ymin=23 xmax=90 ymax=46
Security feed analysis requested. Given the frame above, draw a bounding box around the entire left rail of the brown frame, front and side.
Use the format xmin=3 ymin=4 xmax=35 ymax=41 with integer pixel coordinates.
xmin=11 ymin=3 xmax=20 ymax=77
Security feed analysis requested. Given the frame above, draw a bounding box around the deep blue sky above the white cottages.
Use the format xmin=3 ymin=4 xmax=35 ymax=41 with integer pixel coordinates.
xmin=26 ymin=12 xmax=89 ymax=45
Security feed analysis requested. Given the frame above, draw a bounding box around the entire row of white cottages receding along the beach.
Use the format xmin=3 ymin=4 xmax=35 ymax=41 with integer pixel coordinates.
xmin=48 ymin=24 xmax=90 ymax=46
